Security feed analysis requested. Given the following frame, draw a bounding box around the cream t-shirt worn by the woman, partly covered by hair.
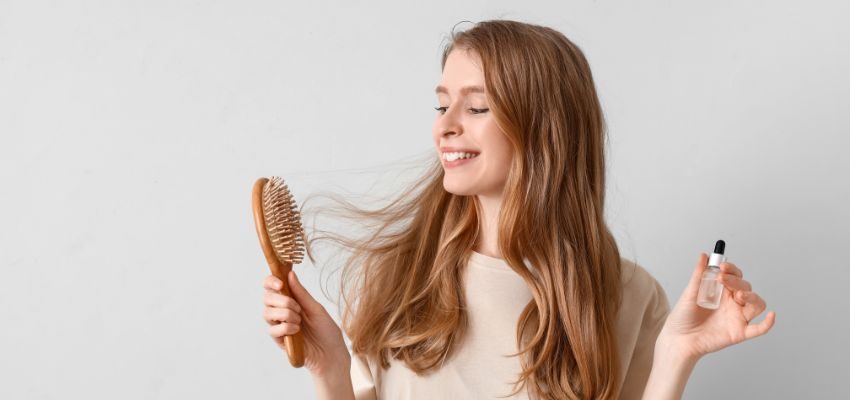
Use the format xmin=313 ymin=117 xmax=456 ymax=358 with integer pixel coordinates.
xmin=351 ymin=251 xmax=670 ymax=400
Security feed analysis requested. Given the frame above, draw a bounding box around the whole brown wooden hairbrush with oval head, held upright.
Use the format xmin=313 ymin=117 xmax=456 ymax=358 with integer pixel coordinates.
xmin=252 ymin=176 xmax=304 ymax=368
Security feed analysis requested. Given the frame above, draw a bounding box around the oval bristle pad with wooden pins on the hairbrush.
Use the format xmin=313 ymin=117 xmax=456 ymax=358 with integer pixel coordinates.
xmin=263 ymin=176 xmax=304 ymax=264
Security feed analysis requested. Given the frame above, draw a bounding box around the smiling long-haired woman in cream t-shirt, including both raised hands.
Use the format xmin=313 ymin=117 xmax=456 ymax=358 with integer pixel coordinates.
xmin=264 ymin=20 xmax=775 ymax=400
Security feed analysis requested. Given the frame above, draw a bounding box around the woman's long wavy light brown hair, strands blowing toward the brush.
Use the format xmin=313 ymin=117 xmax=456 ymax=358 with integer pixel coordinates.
xmin=306 ymin=20 xmax=622 ymax=399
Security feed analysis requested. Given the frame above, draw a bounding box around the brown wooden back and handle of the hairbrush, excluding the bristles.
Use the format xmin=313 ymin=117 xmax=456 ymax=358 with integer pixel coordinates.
xmin=251 ymin=178 xmax=304 ymax=368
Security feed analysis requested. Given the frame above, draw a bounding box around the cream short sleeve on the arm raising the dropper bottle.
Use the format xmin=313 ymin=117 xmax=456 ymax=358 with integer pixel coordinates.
xmin=620 ymin=278 xmax=670 ymax=400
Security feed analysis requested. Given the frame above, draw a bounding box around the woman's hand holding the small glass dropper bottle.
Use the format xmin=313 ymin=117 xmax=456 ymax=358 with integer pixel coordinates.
xmin=656 ymin=253 xmax=776 ymax=360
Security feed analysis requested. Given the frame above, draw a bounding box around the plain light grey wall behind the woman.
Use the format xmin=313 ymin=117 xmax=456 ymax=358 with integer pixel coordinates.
xmin=0 ymin=1 xmax=850 ymax=399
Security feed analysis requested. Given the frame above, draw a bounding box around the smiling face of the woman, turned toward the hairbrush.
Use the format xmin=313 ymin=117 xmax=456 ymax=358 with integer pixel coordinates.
xmin=432 ymin=49 xmax=511 ymax=197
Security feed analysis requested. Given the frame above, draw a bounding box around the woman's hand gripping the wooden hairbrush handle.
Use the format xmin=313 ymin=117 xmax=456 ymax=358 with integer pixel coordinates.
xmin=263 ymin=271 xmax=351 ymax=378
